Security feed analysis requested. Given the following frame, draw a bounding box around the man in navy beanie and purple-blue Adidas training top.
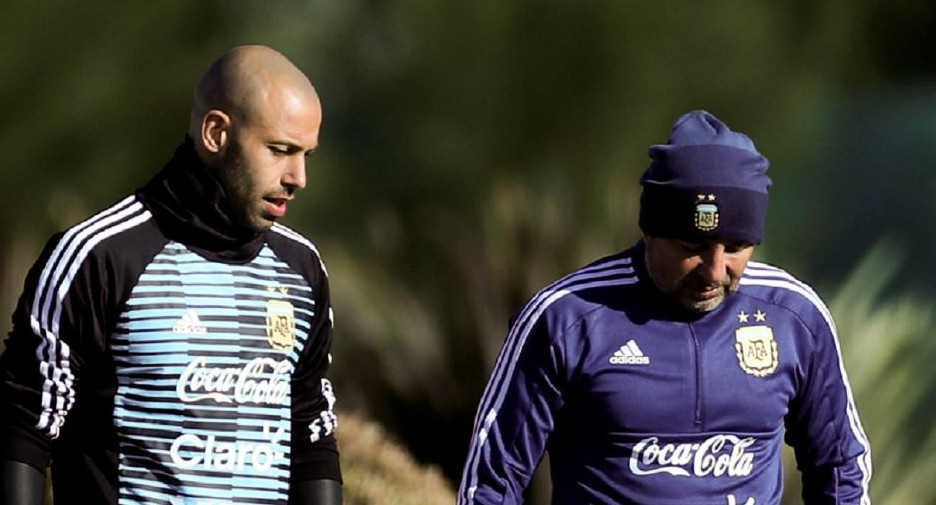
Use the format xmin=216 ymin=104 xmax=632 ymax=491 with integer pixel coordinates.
xmin=458 ymin=111 xmax=871 ymax=505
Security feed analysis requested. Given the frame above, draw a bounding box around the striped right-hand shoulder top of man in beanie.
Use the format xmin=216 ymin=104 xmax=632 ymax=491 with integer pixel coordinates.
xmin=740 ymin=261 xmax=834 ymax=328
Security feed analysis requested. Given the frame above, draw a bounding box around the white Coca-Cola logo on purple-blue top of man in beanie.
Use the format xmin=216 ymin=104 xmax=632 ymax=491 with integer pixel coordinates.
xmin=630 ymin=435 xmax=754 ymax=477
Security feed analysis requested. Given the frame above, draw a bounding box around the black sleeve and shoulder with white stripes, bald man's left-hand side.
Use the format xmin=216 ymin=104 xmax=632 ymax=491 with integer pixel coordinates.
xmin=0 ymin=199 xmax=163 ymax=472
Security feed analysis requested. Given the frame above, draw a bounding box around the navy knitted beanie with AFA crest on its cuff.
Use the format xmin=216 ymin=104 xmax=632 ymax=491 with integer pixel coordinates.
xmin=640 ymin=110 xmax=770 ymax=244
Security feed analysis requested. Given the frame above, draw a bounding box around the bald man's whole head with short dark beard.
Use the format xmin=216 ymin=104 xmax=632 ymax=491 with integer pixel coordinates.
xmin=189 ymin=46 xmax=322 ymax=232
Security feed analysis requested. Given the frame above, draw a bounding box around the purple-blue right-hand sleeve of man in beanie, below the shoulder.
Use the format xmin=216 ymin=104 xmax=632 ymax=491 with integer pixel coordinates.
xmin=786 ymin=307 xmax=871 ymax=505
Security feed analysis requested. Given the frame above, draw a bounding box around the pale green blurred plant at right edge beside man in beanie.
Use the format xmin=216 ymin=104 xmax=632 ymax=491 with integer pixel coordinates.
xmin=812 ymin=242 xmax=936 ymax=505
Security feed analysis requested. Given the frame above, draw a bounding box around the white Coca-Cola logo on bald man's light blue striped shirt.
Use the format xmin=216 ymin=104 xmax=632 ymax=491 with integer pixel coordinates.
xmin=176 ymin=357 xmax=291 ymax=405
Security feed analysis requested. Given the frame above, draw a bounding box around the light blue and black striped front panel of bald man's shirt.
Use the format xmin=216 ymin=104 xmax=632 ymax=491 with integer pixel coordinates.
xmin=111 ymin=242 xmax=317 ymax=505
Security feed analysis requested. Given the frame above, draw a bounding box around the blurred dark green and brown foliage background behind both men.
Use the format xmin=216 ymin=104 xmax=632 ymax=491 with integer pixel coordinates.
xmin=0 ymin=0 xmax=936 ymax=505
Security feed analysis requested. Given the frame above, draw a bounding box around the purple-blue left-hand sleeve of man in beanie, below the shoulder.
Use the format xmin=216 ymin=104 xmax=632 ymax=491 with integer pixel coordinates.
xmin=457 ymin=313 xmax=564 ymax=505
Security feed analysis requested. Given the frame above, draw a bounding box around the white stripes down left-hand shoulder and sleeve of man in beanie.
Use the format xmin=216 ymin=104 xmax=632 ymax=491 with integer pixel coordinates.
xmin=457 ymin=258 xmax=637 ymax=505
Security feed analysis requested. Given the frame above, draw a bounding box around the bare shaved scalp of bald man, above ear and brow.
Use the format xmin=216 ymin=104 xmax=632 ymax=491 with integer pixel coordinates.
xmin=189 ymin=45 xmax=318 ymax=139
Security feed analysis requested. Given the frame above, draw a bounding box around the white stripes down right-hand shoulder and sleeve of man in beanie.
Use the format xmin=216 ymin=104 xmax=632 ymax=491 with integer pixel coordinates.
xmin=741 ymin=261 xmax=872 ymax=505
